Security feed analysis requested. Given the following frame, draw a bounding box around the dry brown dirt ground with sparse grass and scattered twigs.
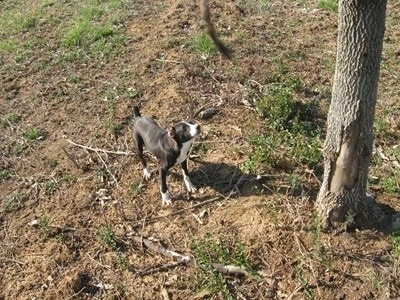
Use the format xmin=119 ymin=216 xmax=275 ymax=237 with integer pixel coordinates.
xmin=0 ymin=0 xmax=400 ymax=299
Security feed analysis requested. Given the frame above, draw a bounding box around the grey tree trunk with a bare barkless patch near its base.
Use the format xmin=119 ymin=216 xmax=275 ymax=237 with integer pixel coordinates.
xmin=316 ymin=0 xmax=387 ymax=229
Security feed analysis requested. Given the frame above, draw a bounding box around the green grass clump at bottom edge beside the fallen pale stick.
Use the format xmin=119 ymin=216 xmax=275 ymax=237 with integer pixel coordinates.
xmin=191 ymin=234 xmax=252 ymax=299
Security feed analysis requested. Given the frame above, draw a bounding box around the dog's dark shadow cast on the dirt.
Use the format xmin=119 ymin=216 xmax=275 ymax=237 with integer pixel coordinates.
xmin=190 ymin=158 xmax=256 ymax=197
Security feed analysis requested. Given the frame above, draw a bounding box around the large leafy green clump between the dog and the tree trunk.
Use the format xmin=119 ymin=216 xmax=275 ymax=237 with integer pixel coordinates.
xmin=243 ymin=75 xmax=322 ymax=172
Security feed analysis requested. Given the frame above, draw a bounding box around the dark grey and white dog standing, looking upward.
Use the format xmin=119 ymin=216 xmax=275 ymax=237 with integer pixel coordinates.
xmin=132 ymin=106 xmax=201 ymax=205
